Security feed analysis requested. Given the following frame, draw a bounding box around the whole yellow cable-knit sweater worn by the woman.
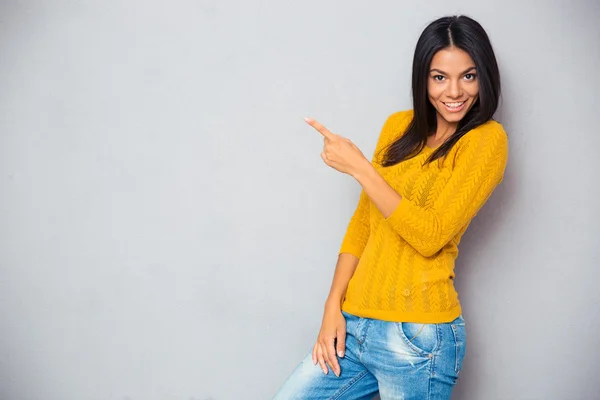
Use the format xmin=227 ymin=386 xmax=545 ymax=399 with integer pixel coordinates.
xmin=340 ymin=111 xmax=508 ymax=323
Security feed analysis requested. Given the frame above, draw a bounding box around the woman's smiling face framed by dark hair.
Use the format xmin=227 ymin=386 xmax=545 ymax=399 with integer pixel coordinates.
xmin=427 ymin=47 xmax=479 ymax=124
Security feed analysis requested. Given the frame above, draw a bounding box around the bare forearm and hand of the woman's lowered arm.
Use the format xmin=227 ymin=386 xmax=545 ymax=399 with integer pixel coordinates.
xmin=312 ymin=253 xmax=358 ymax=376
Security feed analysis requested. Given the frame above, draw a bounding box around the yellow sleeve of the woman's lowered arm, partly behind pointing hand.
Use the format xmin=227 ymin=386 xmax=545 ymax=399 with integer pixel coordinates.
xmin=339 ymin=110 xmax=412 ymax=258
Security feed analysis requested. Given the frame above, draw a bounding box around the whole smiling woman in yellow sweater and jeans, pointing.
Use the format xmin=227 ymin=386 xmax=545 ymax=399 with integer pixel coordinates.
xmin=275 ymin=16 xmax=508 ymax=400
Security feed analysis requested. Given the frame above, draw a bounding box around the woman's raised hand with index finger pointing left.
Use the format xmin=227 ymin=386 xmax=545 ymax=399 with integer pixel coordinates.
xmin=305 ymin=118 xmax=371 ymax=177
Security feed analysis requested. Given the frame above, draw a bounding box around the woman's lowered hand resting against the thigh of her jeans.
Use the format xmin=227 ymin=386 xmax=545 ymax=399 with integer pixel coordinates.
xmin=312 ymin=303 xmax=346 ymax=376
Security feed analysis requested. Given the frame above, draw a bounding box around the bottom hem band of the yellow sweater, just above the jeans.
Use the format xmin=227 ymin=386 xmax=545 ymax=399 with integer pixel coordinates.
xmin=342 ymin=302 xmax=462 ymax=324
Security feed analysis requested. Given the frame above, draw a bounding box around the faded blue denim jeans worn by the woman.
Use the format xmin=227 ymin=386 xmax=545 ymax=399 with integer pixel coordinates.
xmin=274 ymin=311 xmax=466 ymax=400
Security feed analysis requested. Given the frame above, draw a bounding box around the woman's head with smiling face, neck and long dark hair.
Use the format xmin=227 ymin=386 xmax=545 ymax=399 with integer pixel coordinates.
xmin=383 ymin=16 xmax=501 ymax=166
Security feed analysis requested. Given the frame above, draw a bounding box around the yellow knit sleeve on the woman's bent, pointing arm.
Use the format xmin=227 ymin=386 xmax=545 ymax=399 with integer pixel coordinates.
xmin=386 ymin=122 xmax=508 ymax=257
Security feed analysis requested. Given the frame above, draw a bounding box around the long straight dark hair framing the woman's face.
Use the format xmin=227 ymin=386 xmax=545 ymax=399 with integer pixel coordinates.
xmin=382 ymin=16 xmax=500 ymax=167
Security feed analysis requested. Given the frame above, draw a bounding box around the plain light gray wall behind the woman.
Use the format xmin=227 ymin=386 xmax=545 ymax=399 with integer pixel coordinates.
xmin=0 ymin=0 xmax=600 ymax=400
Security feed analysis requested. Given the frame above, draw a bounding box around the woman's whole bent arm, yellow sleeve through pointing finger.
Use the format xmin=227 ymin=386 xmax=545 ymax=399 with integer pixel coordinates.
xmin=307 ymin=120 xmax=508 ymax=257
